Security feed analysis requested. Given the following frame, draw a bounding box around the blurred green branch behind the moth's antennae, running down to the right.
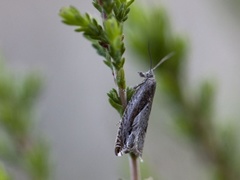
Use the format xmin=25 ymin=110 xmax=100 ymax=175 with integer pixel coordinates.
xmin=125 ymin=4 xmax=240 ymax=180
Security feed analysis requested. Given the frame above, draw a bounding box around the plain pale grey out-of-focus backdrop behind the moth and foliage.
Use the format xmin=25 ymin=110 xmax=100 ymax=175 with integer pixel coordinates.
xmin=0 ymin=0 xmax=240 ymax=180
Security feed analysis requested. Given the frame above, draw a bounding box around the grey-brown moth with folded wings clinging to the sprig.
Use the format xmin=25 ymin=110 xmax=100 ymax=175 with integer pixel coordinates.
xmin=115 ymin=53 xmax=173 ymax=157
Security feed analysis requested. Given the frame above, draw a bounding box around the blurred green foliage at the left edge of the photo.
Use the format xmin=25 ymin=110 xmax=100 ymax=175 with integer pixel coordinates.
xmin=0 ymin=60 xmax=50 ymax=180
